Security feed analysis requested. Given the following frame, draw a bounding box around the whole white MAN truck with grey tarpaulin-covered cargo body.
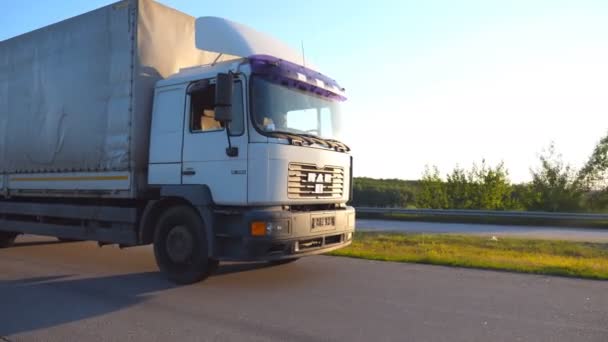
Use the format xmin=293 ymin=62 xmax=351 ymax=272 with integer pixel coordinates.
xmin=0 ymin=0 xmax=355 ymax=284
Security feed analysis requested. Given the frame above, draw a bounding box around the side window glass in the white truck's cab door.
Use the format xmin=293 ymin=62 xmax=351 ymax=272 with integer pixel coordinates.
xmin=190 ymin=81 xmax=244 ymax=135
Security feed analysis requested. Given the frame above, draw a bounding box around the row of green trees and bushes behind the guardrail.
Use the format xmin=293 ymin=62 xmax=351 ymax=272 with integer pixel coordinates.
xmin=352 ymin=135 xmax=608 ymax=212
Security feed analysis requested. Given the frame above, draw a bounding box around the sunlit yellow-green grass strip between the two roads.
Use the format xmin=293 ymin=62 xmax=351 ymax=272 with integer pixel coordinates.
xmin=330 ymin=232 xmax=608 ymax=280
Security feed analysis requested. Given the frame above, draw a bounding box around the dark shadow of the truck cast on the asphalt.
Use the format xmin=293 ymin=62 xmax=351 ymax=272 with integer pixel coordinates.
xmin=0 ymin=263 xmax=282 ymax=336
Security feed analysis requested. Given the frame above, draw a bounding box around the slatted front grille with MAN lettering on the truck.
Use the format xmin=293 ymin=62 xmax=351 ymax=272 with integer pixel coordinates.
xmin=287 ymin=163 xmax=344 ymax=198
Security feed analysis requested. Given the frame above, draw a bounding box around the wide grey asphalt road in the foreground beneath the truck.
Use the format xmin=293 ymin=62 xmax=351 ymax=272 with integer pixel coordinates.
xmin=0 ymin=237 xmax=608 ymax=342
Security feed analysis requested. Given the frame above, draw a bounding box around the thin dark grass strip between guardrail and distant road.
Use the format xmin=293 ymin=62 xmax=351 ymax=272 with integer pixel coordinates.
xmin=357 ymin=213 xmax=608 ymax=229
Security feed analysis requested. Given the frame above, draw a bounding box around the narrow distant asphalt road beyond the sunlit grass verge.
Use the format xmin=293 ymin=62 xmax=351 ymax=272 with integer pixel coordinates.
xmin=357 ymin=219 xmax=608 ymax=243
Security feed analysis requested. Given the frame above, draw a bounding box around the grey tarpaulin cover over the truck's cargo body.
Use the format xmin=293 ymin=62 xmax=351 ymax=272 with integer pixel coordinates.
xmin=0 ymin=0 xmax=230 ymax=178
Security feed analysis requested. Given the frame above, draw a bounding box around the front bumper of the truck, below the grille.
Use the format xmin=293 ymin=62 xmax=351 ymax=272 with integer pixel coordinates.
xmin=214 ymin=207 xmax=355 ymax=261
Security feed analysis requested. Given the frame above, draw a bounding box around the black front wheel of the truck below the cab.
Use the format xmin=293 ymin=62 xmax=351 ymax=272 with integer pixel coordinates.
xmin=154 ymin=206 xmax=213 ymax=284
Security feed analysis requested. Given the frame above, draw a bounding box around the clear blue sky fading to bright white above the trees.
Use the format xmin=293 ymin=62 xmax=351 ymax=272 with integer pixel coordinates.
xmin=0 ymin=0 xmax=608 ymax=181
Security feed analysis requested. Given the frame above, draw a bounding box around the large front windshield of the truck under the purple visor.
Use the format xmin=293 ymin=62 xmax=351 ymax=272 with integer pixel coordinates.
xmin=251 ymin=76 xmax=342 ymax=140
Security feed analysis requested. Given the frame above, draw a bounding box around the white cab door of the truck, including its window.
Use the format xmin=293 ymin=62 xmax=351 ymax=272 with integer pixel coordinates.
xmin=182 ymin=78 xmax=247 ymax=205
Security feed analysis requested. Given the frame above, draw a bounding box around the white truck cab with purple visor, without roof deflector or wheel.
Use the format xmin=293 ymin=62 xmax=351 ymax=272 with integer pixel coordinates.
xmin=148 ymin=55 xmax=355 ymax=268
